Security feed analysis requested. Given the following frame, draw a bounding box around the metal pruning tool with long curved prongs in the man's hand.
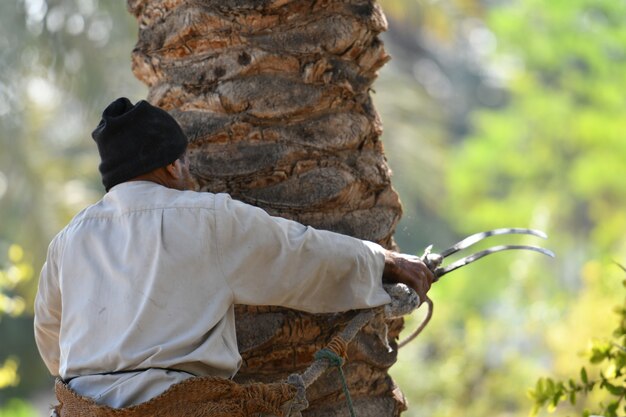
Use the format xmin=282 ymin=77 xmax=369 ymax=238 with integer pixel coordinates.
xmin=398 ymin=227 xmax=554 ymax=347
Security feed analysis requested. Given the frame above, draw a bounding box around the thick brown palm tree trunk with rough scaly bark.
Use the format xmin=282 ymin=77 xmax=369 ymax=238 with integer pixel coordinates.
xmin=128 ymin=0 xmax=405 ymax=417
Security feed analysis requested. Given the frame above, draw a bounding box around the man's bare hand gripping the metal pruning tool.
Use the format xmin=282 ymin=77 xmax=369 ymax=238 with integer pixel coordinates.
xmin=383 ymin=251 xmax=435 ymax=302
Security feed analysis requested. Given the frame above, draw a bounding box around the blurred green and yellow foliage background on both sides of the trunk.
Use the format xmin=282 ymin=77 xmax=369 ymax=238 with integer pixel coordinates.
xmin=0 ymin=0 xmax=626 ymax=417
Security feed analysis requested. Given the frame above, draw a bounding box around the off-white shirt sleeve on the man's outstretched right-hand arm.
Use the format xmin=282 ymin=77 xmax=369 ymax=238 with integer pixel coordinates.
xmin=216 ymin=194 xmax=390 ymax=313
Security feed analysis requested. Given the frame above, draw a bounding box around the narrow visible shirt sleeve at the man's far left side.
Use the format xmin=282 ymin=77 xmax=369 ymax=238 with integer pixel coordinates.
xmin=35 ymin=236 xmax=61 ymax=376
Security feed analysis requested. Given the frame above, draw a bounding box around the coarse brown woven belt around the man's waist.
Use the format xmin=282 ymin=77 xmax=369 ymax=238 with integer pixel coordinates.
xmin=54 ymin=377 xmax=296 ymax=417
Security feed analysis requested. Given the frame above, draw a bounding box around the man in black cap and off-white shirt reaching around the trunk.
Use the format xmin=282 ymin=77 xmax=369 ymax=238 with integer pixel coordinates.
xmin=35 ymin=98 xmax=433 ymax=408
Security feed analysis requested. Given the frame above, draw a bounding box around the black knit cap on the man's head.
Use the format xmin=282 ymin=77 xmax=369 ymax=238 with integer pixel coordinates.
xmin=91 ymin=97 xmax=187 ymax=191
